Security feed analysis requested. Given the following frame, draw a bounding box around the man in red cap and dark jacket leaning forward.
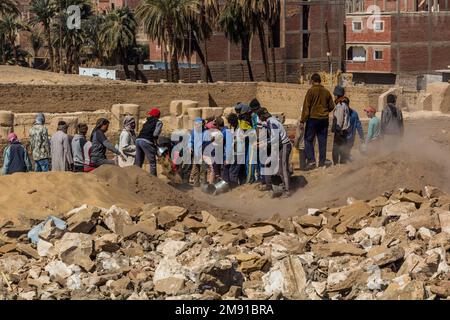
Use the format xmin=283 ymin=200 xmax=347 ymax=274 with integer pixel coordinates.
xmin=134 ymin=108 xmax=163 ymax=176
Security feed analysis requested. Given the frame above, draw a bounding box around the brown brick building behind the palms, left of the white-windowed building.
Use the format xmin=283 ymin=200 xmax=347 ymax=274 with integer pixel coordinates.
xmin=150 ymin=0 xmax=345 ymax=82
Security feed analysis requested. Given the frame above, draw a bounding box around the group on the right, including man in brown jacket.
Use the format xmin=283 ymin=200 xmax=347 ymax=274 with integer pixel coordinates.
xmin=297 ymin=74 xmax=404 ymax=170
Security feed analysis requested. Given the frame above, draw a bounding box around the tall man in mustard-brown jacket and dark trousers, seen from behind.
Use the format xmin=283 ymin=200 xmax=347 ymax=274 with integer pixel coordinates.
xmin=300 ymin=73 xmax=334 ymax=170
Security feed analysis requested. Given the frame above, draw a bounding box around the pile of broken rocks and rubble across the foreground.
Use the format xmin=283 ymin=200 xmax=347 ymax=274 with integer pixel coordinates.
xmin=0 ymin=186 xmax=450 ymax=300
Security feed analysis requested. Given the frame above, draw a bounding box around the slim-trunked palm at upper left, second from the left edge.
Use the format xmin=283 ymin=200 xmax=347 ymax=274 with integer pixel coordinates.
xmin=30 ymin=0 xmax=56 ymax=71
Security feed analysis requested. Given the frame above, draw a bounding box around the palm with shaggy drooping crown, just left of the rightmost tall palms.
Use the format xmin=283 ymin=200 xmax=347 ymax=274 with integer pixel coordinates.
xmin=218 ymin=0 xmax=254 ymax=81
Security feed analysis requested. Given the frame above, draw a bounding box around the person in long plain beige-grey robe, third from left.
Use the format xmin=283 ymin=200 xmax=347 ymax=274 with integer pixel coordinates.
xmin=50 ymin=121 xmax=73 ymax=171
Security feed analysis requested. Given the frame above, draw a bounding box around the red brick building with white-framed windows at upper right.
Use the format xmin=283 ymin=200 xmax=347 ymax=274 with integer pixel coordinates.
xmin=346 ymin=0 xmax=450 ymax=84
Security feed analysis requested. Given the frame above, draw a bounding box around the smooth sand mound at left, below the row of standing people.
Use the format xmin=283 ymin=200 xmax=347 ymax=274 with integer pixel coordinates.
xmin=0 ymin=166 xmax=237 ymax=222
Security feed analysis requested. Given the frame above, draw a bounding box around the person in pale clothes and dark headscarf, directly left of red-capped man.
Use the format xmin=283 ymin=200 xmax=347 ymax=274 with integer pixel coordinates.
xmin=118 ymin=115 xmax=136 ymax=167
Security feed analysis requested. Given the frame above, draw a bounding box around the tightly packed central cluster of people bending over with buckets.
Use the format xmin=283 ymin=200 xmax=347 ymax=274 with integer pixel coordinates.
xmin=174 ymin=98 xmax=292 ymax=196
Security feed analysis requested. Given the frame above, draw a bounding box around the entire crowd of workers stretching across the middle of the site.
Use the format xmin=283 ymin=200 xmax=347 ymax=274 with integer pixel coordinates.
xmin=2 ymin=74 xmax=403 ymax=197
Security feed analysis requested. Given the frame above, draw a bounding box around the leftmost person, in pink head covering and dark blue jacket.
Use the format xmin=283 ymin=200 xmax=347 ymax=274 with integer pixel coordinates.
xmin=2 ymin=132 xmax=32 ymax=175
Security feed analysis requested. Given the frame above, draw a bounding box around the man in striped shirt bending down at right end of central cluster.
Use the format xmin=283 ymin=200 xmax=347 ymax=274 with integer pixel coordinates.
xmin=257 ymin=108 xmax=292 ymax=197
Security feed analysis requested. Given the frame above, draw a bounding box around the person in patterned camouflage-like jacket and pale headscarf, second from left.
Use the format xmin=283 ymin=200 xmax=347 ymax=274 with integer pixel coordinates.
xmin=29 ymin=113 xmax=51 ymax=172
